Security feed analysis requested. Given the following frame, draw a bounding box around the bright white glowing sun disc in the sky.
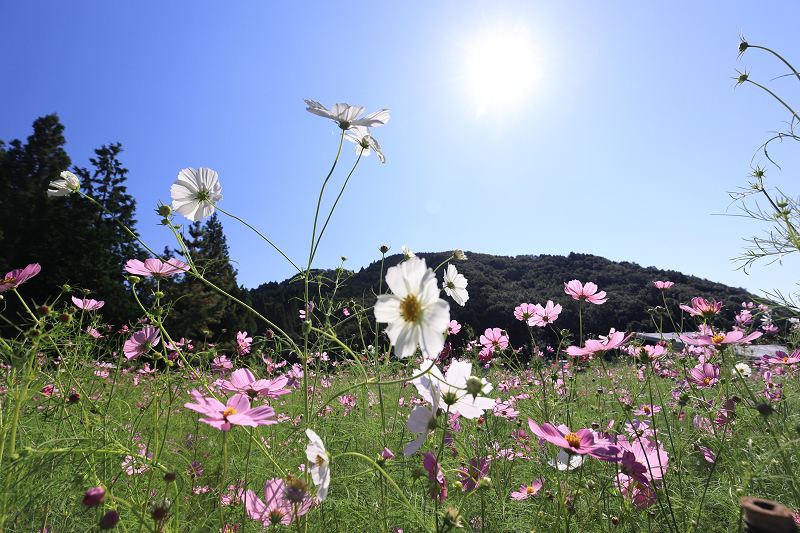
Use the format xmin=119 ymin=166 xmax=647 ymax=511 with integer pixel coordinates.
xmin=465 ymin=26 xmax=542 ymax=116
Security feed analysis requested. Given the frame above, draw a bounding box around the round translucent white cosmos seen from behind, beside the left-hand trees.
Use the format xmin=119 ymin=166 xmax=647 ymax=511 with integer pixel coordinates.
xmin=169 ymin=168 xmax=222 ymax=222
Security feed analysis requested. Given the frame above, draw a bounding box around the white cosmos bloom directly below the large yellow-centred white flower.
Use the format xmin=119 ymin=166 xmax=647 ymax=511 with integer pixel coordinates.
xmin=411 ymin=361 xmax=495 ymax=419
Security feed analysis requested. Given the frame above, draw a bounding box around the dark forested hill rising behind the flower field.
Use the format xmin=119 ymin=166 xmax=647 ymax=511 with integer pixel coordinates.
xmin=250 ymin=252 xmax=755 ymax=352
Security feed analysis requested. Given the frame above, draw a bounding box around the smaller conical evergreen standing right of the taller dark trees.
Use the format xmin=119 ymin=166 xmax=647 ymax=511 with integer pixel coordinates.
xmin=162 ymin=213 xmax=256 ymax=349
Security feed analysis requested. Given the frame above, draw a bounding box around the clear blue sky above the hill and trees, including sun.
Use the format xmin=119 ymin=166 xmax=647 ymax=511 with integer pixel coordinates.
xmin=0 ymin=0 xmax=800 ymax=304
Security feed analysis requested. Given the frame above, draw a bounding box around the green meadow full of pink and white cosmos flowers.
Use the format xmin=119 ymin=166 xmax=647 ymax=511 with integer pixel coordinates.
xmin=0 ymin=42 xmax=800 ymax=533
